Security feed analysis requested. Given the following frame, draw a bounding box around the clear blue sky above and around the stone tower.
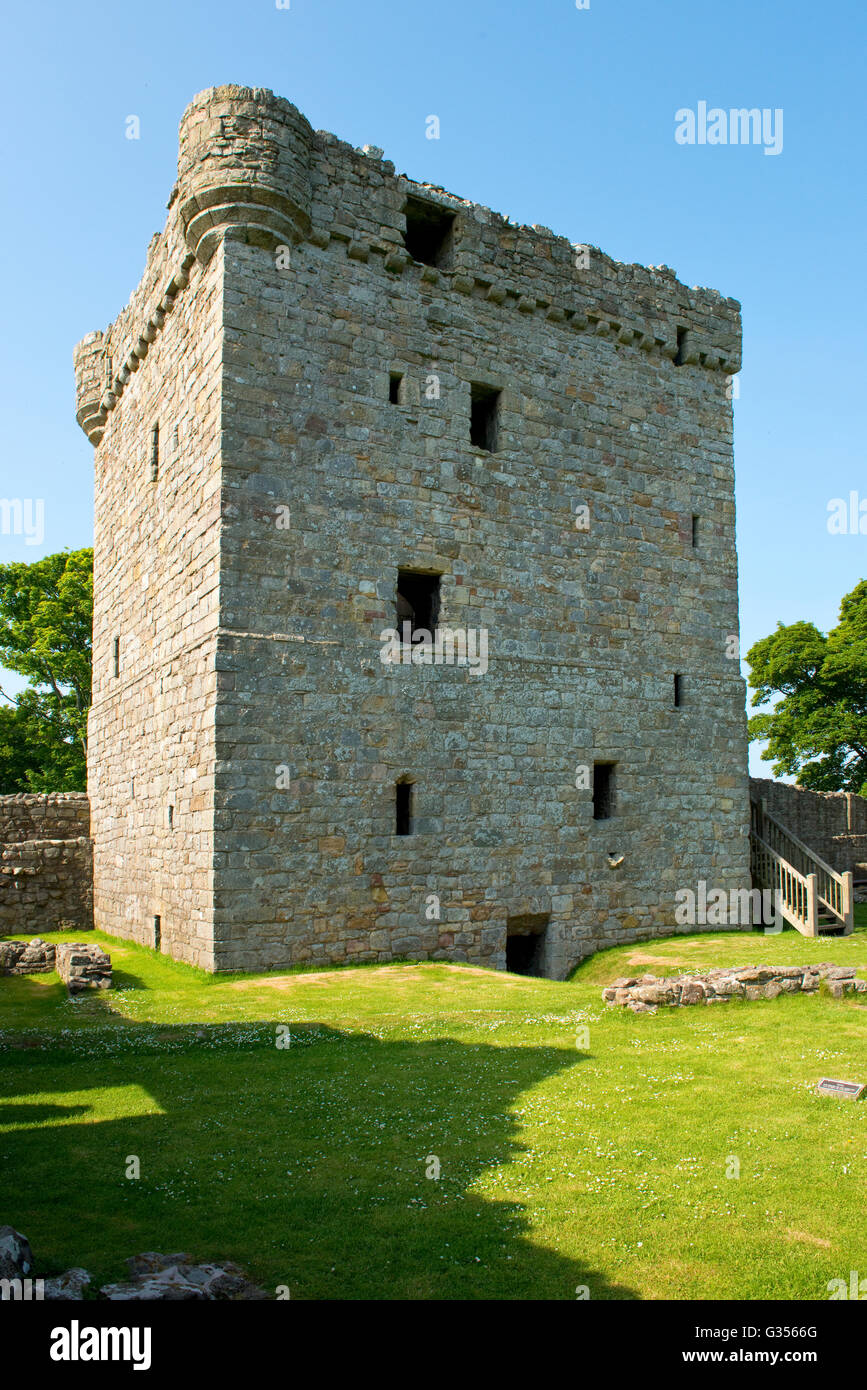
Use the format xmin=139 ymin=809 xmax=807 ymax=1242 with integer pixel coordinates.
xmin=0 ymin=0 xmax=867 ymax=774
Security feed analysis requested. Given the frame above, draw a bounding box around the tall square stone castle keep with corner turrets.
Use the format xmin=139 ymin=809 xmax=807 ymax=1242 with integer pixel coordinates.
xmin=75 ymin=86 xmax=749 ymax=977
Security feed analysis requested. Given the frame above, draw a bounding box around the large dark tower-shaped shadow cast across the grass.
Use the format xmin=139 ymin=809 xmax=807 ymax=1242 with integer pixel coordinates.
xmin=0 ymin=1023 xmax=636 ymax=1300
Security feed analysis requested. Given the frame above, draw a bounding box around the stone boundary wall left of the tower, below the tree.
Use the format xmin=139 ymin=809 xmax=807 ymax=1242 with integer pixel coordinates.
xmin=0 ymin=792 xmax=93 ymax=937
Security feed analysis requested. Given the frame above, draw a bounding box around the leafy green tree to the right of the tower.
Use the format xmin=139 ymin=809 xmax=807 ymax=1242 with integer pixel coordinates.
xmin=746 ymin=580 xmax=867 ymax=795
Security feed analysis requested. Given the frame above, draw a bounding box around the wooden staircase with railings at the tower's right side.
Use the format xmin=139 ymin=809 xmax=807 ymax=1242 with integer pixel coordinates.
xmin=750 ymin=799 xmax=854 ymax=937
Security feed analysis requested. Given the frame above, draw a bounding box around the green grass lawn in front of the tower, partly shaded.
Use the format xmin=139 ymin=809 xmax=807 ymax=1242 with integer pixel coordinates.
xmin=0 ymin=909 xmax=867 ymax=1300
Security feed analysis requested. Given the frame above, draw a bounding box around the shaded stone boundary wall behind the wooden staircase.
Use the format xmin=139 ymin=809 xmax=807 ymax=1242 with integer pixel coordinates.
xmin=750 ymin=777 xmax=867 ymax=878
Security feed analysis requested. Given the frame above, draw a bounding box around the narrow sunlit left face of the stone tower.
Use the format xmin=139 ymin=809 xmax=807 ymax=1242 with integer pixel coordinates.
xmin=76 ymin=201 xmax=222 ymax=969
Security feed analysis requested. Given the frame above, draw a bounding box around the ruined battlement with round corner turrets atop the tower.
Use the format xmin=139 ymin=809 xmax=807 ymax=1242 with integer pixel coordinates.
xmin=75 ymin=86 xmax=741 ymax=443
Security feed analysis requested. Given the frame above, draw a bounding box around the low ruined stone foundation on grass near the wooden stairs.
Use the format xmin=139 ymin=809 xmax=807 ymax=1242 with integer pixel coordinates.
xmin=602 ymin=960 xmax=867 ymax=1013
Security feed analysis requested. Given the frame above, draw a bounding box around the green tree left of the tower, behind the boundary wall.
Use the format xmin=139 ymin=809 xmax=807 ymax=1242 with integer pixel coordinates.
xmin=0 ymin=549 xmax=93 ymax=792
